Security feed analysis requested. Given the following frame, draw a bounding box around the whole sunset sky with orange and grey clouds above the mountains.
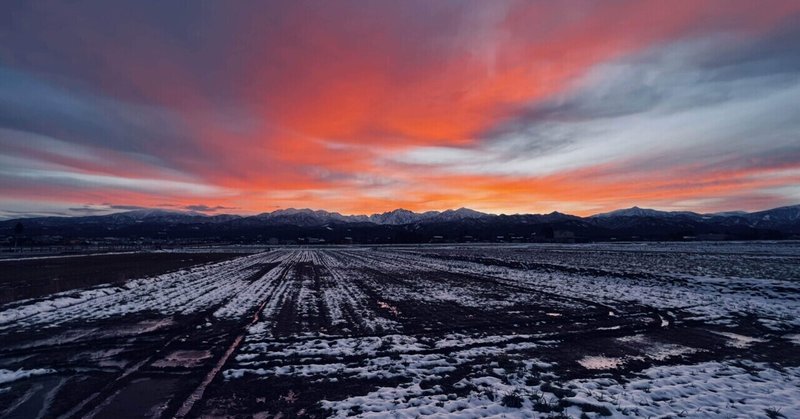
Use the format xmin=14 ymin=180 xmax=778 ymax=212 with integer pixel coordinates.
xmin=0 ymin=0 xmax=800 ymax=218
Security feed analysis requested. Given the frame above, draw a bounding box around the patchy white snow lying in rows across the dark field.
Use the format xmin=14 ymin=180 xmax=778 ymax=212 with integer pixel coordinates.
xmin=0 ymin=244 xmax=800 ymax=418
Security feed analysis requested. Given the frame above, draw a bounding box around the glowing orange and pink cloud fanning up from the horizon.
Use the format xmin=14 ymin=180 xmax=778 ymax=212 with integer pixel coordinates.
xmin=0 ymin=0 xmax=800 ymax=220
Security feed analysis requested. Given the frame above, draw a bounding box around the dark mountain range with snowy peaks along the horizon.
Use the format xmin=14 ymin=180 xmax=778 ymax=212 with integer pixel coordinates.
xmin=0 ymin=205 xmax=800 ymax=243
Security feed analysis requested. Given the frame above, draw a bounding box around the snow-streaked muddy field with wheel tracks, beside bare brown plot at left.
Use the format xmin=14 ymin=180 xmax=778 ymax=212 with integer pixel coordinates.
xmin=0 ymin=243 xmax=800 ymax=418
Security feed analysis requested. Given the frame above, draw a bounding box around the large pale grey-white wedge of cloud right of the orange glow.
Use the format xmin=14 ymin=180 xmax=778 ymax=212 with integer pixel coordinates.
xmin=398 ymin=20 xmax=800 ymax=182
